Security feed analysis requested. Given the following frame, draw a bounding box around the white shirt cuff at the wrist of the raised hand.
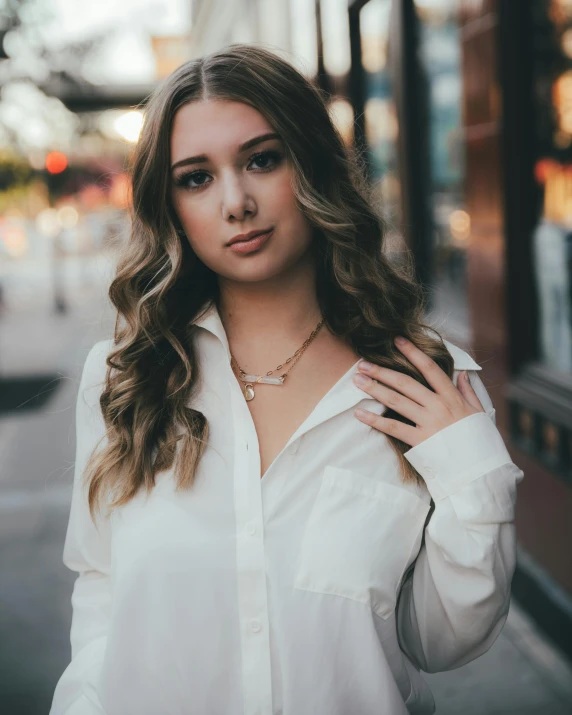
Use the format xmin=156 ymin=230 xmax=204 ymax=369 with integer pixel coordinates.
xmin=404 ymin=412 xmax=512 ymax=501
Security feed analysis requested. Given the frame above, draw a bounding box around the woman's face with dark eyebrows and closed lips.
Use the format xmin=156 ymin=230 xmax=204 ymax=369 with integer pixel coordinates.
xmin=171 ymin=100 xmax=312 ymax=282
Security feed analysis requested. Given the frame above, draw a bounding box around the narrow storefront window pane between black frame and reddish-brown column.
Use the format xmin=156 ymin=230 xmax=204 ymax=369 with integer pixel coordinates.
xmin=415 ymin=0 xmax=471 ymax=344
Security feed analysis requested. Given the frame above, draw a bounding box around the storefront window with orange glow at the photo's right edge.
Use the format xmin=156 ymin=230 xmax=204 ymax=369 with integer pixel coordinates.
xmin=533 ymin=0 xmax=572 ymax=373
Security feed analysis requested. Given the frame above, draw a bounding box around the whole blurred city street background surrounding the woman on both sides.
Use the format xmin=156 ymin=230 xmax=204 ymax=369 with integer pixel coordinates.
xmin=0 ymin=0 xmax=572 ymax=715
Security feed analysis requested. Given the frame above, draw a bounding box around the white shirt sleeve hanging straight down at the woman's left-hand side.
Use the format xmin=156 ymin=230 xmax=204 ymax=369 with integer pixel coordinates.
xmin=50 ymin=341 xmax=111 ymax=715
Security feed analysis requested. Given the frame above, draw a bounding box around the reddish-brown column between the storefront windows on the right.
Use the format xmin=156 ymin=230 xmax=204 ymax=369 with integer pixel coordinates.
xmin=460 ymin=0 xmax=509 ymax=426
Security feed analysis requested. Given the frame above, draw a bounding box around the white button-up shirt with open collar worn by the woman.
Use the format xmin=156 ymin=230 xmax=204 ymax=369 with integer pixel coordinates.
xmin=50 ymin=306 xmax=523 ymax=715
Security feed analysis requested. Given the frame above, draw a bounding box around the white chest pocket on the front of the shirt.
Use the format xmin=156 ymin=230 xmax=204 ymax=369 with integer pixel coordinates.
xmin=294 ymin=466 xmax=430 ymax=618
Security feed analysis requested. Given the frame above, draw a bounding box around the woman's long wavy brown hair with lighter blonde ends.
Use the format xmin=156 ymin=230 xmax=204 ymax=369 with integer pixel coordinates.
xmin=85 ymin=44 xmax=453 ymax=517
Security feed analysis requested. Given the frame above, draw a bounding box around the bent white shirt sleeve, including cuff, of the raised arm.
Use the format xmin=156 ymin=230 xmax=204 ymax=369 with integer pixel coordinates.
xmin=397 ymin=370 xmax=524 ymax=673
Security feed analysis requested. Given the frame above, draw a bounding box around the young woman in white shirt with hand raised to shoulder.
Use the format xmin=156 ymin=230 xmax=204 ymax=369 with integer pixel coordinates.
xmin=51 ymin=44 xmax=523 ymax=715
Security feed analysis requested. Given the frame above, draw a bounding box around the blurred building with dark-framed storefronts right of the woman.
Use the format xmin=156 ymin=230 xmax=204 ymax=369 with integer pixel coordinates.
xmin=191 ymin=0 xmax=572 ymax=654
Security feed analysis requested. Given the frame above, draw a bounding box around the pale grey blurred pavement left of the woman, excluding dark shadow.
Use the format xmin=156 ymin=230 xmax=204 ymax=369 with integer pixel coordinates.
xmin=0 ymin=272 xmax=113 ymax=715
